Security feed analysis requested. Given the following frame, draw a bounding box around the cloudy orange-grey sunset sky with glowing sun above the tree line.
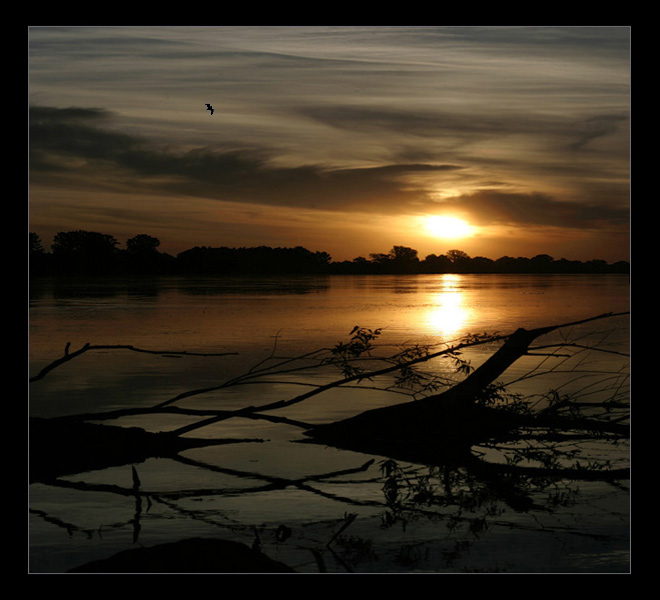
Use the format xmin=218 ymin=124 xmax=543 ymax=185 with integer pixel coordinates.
xmin=28 ymin=26 xmax=631 ymax=262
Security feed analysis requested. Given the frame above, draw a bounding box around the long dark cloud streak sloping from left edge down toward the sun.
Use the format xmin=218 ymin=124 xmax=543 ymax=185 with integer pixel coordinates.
xmin=30 ymin=107 xmax=461 ymax=211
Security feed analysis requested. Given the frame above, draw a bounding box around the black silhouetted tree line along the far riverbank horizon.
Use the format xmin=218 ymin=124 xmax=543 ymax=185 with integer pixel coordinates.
xmin=29 ymin=230 xmax=630 ymax=277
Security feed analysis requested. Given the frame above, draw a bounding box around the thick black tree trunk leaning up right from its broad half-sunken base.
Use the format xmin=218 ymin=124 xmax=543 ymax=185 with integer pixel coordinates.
xmin=306 ymin=315 xmax=629 ymax=464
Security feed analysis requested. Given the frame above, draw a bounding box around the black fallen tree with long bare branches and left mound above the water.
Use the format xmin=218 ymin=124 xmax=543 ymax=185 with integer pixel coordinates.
xmin=30 ymin=313 xmax=628 ymax=480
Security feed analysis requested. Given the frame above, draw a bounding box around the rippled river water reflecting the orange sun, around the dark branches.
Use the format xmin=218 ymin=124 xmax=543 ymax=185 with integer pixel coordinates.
xmin=29 ymin=275 xmax=630 ymax=573
